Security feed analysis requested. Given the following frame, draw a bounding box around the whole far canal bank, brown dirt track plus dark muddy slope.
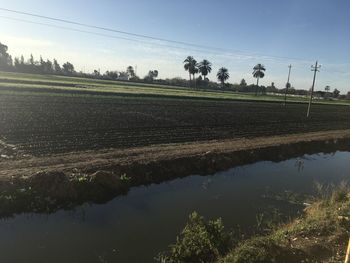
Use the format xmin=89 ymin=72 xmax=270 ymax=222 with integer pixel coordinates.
xmin=0 ymin=130 xmax=350 ymax=217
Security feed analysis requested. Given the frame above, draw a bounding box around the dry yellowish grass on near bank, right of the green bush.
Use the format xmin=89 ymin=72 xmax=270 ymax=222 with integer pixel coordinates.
xmin=219 ymin=183 xmax=350 ymax=262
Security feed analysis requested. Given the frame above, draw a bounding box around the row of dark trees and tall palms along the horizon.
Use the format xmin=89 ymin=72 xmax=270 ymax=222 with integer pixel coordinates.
xmin=0 ymin=42 xmax=350 ymax=99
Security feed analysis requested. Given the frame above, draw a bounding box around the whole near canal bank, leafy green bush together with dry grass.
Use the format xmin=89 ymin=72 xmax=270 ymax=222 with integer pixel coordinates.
xmin=157 ymin=186 xmax=350 ymax=263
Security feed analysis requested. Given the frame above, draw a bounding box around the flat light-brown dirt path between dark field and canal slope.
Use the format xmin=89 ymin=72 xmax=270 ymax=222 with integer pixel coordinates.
xmin=0 ymin=129 xmax=350 ymax=180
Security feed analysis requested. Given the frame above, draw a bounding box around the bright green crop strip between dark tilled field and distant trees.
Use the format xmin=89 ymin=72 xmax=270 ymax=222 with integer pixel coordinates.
xmin=0 ymin=72 xmax=350 ymax=105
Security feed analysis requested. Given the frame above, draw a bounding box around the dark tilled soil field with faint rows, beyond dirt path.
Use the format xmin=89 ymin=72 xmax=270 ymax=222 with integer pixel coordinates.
xmin=0 ymin=95 xmax=350 ymax=156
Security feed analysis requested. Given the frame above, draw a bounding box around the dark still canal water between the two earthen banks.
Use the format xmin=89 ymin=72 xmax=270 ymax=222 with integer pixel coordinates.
xmin=0 ymin=151 xmax=350 ymax=263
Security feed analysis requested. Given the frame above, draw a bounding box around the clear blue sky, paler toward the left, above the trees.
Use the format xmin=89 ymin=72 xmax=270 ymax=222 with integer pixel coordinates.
xmin=0 ymin=0 xmax=350 ymax=93
